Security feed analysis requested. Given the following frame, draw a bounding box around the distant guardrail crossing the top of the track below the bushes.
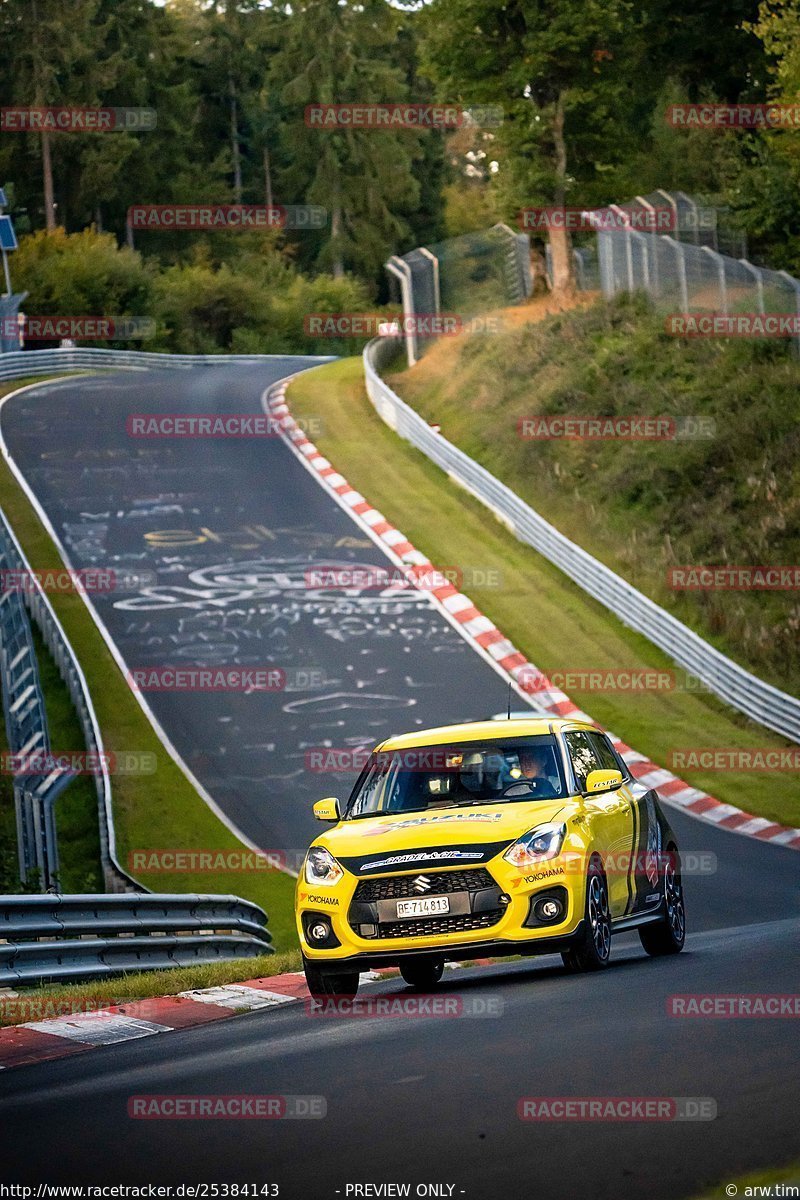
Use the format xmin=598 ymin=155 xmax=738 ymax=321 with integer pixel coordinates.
xmin=0 ymin=347 xmax=330 ymax=380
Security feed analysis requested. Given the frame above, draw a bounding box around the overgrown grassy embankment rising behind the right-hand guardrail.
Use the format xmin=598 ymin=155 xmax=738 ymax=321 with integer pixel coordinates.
xmin=387 ymin=292 xmax=800 ymax=695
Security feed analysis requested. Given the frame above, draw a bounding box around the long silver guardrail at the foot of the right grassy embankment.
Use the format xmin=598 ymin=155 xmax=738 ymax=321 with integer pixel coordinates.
xmin=363 ymin=338 xmax=800 ymax=742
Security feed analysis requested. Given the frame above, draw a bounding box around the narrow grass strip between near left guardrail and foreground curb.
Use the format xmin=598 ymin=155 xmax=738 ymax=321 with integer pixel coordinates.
xmin=0 ymin=950 xmax=301 ymax=1026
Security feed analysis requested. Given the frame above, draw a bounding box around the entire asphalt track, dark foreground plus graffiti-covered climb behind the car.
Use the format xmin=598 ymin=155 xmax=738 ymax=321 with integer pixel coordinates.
xmin=0 ymin=360 xmax=800 ymax=1200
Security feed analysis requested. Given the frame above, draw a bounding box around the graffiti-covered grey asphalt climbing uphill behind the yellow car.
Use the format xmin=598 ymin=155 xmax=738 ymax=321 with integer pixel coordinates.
xmin=2 ymin=359 xmax=520 ymax=856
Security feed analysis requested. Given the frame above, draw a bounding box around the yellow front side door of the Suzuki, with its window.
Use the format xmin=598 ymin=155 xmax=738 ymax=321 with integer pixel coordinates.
xmin=564 ymin=730 xmax=633 ymax=917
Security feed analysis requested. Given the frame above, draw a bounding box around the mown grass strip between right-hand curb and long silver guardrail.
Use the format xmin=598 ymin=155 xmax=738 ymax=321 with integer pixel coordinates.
xmin=289 ymin=359 xmax=800 ymax=826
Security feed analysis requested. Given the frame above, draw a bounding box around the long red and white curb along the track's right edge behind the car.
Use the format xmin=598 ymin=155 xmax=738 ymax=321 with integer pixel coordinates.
xmin=264 ymin=377 xmax=800 ymax=850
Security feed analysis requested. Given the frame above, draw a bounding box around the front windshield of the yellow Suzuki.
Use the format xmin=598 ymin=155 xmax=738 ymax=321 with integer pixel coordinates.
xmin=344 ymin=734 xmax=566 ymax=821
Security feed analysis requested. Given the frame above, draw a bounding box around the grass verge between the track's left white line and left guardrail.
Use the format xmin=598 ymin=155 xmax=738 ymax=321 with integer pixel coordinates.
xmin=0 ymin=382 xmax=296 ymax=950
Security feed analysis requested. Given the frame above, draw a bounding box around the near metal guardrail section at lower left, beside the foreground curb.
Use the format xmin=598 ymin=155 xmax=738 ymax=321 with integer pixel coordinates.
xmin=0 ymin=893 xmax=272 ymax=986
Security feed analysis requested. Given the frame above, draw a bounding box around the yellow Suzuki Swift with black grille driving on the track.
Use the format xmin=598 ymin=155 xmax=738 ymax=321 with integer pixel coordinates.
xmin=296 ymin=716 xmax=686 ymax=996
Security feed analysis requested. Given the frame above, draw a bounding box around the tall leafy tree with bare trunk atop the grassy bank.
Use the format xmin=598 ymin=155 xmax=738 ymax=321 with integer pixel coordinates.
xmin=423 ymin=0 xmax=631 ymax=292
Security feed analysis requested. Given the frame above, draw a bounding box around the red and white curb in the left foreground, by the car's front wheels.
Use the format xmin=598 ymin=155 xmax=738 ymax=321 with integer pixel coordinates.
xmin=0 ymin=959 xmax=489 ymax=1070
